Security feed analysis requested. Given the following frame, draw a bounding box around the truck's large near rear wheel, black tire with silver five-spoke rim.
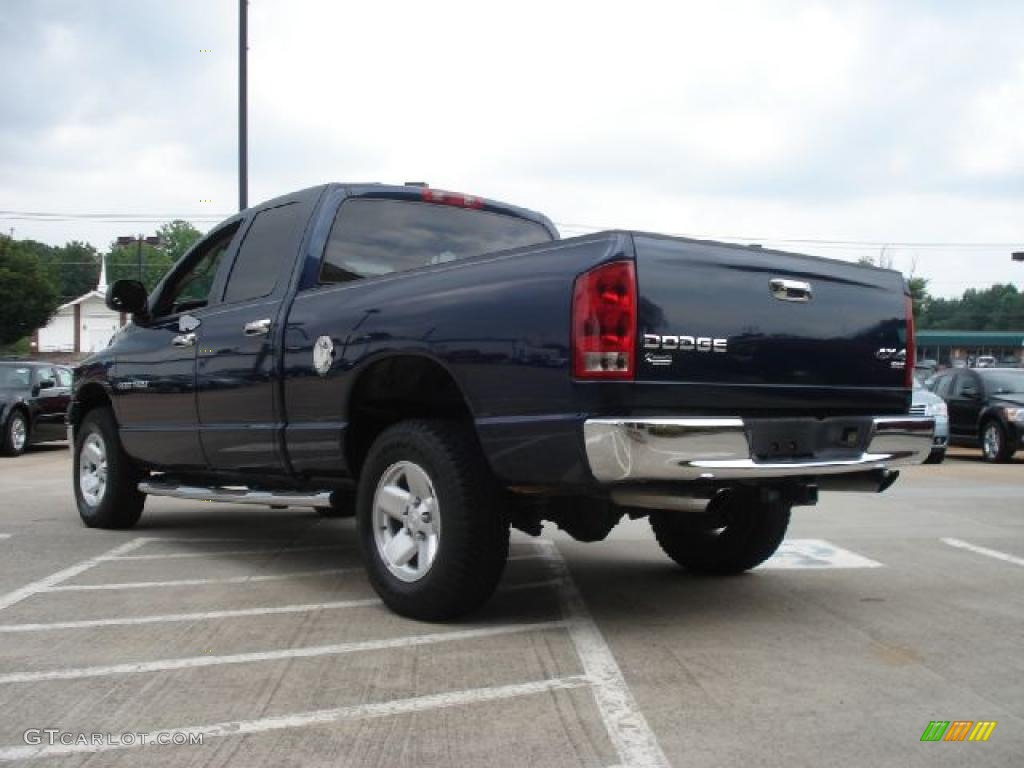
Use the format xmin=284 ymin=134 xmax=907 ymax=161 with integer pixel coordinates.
xmin=356 ymin=420 xmax=509 ymax=622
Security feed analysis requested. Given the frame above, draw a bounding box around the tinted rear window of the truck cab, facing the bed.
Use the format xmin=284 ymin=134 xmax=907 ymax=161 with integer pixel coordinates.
xmin=319 ymin=199 xmax=551 ymax=283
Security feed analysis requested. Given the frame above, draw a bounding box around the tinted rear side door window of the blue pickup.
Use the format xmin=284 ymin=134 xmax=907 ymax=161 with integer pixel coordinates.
xmin=224 ymin=203 xmax=306 ymax=303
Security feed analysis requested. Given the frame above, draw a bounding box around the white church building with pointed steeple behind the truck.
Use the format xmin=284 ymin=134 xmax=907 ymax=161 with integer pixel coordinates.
xmin=32 ymin=259 xmax=126 ymax=354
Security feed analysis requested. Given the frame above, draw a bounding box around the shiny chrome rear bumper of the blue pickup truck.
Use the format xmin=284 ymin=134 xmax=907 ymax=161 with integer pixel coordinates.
xmin=584 ymin=416 xmax=935 ymax=482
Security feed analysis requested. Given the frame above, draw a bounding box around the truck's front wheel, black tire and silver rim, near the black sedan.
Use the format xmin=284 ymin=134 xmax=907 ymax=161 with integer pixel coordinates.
xmin=72 ymin=408 xmax=145 ymax=528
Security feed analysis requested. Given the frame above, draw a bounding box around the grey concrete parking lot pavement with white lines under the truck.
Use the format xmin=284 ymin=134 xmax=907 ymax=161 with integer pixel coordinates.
xmin=0 ymin=447 xmax=1024 ymax=768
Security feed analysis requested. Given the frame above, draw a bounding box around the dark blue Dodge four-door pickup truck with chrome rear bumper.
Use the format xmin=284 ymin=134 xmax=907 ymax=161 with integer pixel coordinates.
xmin=69 ymin=184 xmax=933 ymax=620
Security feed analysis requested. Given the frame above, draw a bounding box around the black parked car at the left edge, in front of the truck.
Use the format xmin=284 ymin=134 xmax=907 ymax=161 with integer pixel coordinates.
xmin=0 ymin=360 xmax=72 ymax=456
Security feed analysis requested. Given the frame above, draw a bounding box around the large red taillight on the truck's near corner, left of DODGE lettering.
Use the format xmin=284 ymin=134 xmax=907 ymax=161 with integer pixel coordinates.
xmin=572 ymin=261 xmax=637 ymax=379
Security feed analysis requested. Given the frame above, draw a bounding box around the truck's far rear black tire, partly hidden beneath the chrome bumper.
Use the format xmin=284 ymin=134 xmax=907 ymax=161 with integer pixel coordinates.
xmin=650 ymin=490 xmax=791 ymax=575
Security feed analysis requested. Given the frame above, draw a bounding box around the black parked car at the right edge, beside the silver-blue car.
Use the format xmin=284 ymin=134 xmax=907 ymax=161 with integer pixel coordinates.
xmin=932 ymin=368 xmax=1024 ymax=462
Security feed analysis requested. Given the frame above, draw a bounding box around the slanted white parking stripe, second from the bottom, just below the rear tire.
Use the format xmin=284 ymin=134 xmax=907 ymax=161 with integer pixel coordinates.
xmin=0 ymin=622 xmax=569 ymax=684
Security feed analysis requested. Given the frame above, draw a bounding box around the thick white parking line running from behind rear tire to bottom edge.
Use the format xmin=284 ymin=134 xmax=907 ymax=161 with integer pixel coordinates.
xmin=537 ymin=539 xmax=669 ymax=768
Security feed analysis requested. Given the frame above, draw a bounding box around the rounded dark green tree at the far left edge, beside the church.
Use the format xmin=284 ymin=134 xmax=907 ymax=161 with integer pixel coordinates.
xmin=0 ymin=236 xmax=60 ymax=345
